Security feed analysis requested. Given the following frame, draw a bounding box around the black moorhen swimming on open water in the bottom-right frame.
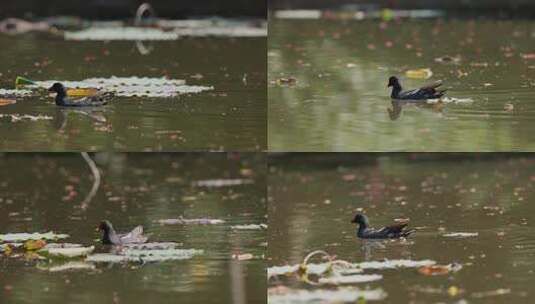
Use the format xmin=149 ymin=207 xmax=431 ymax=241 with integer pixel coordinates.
xmin=351 ymin=214 xmax=415 ymax=239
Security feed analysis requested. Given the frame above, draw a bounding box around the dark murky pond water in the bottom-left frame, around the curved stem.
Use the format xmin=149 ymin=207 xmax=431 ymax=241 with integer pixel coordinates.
xmin=0 ymin=153 xmax=266 ymax=303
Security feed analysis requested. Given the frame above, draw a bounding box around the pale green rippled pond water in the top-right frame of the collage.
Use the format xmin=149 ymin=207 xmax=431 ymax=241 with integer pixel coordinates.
xmin=268 ymin=19 xmax=535 ymax=151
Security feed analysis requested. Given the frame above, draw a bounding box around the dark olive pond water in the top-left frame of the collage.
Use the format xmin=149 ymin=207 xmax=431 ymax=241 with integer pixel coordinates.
xmin=0 ymin=34 xmax=267 ymax=151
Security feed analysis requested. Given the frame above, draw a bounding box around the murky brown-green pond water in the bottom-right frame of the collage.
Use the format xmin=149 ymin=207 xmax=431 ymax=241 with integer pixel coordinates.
xmin=268 ymin=154 xmax=535 ymax=303
